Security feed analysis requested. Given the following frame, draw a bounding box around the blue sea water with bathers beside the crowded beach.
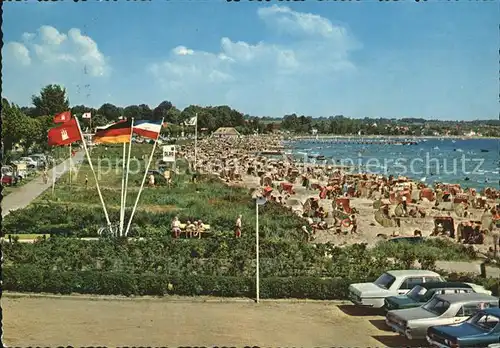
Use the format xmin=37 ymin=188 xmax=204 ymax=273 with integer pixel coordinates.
xmin=285 ymin=138 xmax=500 ymax=189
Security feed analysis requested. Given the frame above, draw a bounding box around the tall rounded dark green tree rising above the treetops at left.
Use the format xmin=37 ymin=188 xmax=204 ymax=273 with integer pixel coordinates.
xmin=31 ymin=85 xmax=69 ymax=116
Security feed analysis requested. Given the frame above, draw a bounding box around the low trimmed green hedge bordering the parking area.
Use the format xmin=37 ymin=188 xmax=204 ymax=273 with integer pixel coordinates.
xmin=3 ymin=265 xmax=500 ymax=300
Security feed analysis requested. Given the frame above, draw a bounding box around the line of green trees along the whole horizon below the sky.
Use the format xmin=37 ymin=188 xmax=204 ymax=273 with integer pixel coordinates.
xmin=2 ymin=85 xmax=500 ymax=157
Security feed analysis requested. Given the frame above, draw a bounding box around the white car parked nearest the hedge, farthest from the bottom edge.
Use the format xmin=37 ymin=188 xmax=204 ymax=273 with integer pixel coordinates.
xmin=349 ymin=270 xmax=444 ymax=308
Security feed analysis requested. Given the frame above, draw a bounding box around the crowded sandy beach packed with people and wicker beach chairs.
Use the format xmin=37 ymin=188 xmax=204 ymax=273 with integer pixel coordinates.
xmin=179 ymin=135 xmax=500 ymax=254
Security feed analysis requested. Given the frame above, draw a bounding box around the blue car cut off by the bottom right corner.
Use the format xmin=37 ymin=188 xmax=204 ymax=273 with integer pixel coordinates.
xmin=427 ymin=308 xmax=500 ymax=348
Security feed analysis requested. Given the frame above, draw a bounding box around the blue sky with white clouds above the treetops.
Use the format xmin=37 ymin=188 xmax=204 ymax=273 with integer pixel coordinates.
xmin=2 ymin=0 xmax=500 ymax=120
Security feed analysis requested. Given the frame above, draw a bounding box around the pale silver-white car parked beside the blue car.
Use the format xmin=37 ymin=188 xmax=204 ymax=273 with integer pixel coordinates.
xmin=385 ymin=293 xmax=498 ymax=340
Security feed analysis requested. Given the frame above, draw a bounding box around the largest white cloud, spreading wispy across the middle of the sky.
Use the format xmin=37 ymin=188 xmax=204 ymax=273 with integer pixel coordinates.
xmin=149 ymin=5 xmax=357 ymax=110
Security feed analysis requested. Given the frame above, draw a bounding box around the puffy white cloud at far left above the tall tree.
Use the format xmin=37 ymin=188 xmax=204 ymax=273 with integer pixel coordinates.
xmin=6 ymin=25 xmax=109 ymax=76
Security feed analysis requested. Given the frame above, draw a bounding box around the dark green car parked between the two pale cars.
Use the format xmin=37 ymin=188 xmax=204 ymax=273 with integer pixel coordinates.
xmin=384 ymin=282 xmax=491 ymax=310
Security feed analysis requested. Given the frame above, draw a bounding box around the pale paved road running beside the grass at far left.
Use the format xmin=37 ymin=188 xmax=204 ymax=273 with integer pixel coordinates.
xmin=2 ymin=151 xmax=85 ymax=217
